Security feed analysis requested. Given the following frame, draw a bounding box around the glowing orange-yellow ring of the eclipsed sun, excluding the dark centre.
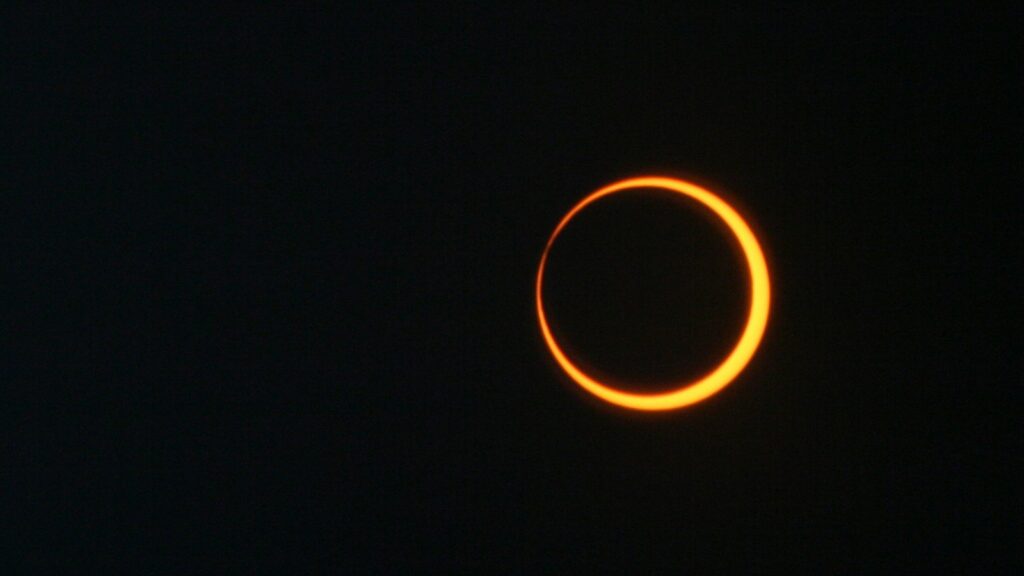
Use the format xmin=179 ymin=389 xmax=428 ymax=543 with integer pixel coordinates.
xmin=537 ymin=176 xmax=770 ymax=411
